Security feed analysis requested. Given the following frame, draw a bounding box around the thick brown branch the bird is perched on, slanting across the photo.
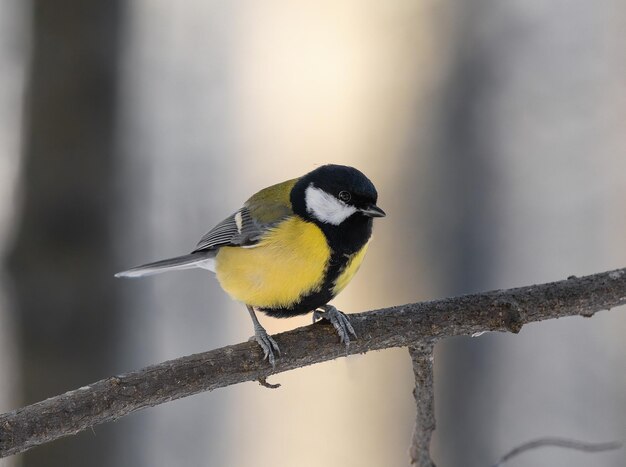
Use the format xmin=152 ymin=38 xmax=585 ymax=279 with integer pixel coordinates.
xmin=0 ymin=268 xmax=626 ymax=457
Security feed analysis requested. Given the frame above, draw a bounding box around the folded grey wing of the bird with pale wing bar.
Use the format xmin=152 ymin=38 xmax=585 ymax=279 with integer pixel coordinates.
xmin=192 ymin=207 xmax=266 ymax=253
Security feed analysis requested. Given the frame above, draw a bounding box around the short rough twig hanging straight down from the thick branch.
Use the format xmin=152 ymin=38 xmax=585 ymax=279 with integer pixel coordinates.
xmin=409 ymin=340 xmax=435 ymax=467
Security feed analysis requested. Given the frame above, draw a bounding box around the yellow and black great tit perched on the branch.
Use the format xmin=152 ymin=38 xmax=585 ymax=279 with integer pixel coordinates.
xmin=115 ymin=164 xmax=386 ymax=367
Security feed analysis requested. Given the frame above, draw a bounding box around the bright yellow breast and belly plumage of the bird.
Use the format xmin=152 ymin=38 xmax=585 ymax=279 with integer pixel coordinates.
xmin=215 ymin=217 xmax=330 ymax=308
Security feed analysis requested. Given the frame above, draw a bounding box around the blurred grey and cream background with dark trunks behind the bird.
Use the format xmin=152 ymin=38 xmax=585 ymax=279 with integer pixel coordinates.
xmin=0 ymin=0 xmax=626 ymax=467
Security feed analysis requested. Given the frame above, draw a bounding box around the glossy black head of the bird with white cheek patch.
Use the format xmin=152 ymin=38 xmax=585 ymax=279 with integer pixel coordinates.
xmin=291 ymin=164 xmax=385 ymax=225
